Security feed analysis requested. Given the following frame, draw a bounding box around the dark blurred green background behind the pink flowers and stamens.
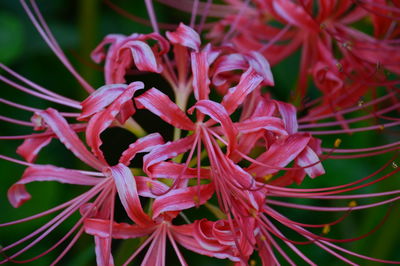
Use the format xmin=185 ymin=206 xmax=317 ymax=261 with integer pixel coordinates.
xmin=0 ymin=0 xmax=400 ymax=265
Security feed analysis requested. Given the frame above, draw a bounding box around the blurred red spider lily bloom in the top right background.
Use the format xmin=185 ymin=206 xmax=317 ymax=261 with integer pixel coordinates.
xmin=190 ymin=0 xmax=400 ymax=115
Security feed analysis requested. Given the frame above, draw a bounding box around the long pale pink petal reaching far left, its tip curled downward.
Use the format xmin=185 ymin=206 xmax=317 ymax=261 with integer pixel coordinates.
xmin=8 ymin=165 xmax=102 ymax=208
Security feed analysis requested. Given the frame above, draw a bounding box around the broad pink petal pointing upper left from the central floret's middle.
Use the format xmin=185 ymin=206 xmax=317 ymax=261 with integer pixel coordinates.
xmin=135 ymin=88 xmax=195 ymax=130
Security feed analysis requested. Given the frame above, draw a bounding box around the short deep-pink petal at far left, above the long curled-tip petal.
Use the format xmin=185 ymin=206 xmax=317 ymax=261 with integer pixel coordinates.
xmin=17 ymin=136 xmax=52 ymax=163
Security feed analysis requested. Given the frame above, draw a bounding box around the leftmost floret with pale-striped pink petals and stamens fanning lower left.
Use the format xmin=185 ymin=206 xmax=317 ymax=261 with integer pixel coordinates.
xmin=1 ymin=103 xmax=167 ymax=265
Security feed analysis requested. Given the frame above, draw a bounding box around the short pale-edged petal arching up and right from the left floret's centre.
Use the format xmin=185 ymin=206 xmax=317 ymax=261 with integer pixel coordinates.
xmin=119 ymin=133 xmax=164 ymax=165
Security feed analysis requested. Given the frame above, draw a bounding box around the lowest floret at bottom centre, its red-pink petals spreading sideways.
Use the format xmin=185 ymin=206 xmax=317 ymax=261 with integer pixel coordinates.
xmin=85 ymin=175 xmax=222 ymax=265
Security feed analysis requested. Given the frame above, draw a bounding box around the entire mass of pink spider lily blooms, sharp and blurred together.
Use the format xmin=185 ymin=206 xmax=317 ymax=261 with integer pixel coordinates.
xmin=0 ymin=0 xmax=400 ymax=265
